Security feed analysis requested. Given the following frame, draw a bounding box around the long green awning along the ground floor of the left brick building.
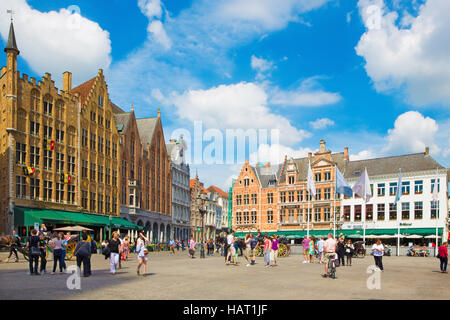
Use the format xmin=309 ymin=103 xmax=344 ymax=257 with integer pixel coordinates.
xmin=14 ymin=207 xmax=142 ymax=230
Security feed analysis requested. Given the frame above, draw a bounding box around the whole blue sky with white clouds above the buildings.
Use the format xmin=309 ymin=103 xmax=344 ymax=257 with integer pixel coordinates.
xmin=0 ymin=0 xmax=450 ymax=188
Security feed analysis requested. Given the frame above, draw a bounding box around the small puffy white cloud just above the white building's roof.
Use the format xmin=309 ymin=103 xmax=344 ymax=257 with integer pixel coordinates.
xmin=382 ymin=111 xmax=440 ymax=154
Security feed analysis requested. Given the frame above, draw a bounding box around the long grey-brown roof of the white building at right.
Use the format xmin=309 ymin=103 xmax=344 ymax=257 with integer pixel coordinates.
xmin=343 ymin=152 xmax=445 ymax=178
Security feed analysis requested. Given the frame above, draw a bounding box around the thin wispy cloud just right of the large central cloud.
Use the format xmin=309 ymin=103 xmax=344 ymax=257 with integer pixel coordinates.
xmin=270 ymin=77 xmax=342 ymax=107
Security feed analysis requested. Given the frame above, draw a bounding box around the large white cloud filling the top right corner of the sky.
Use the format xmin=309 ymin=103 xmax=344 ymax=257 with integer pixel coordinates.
xmin=356 ymin=0 xmax=450 ymax=106
